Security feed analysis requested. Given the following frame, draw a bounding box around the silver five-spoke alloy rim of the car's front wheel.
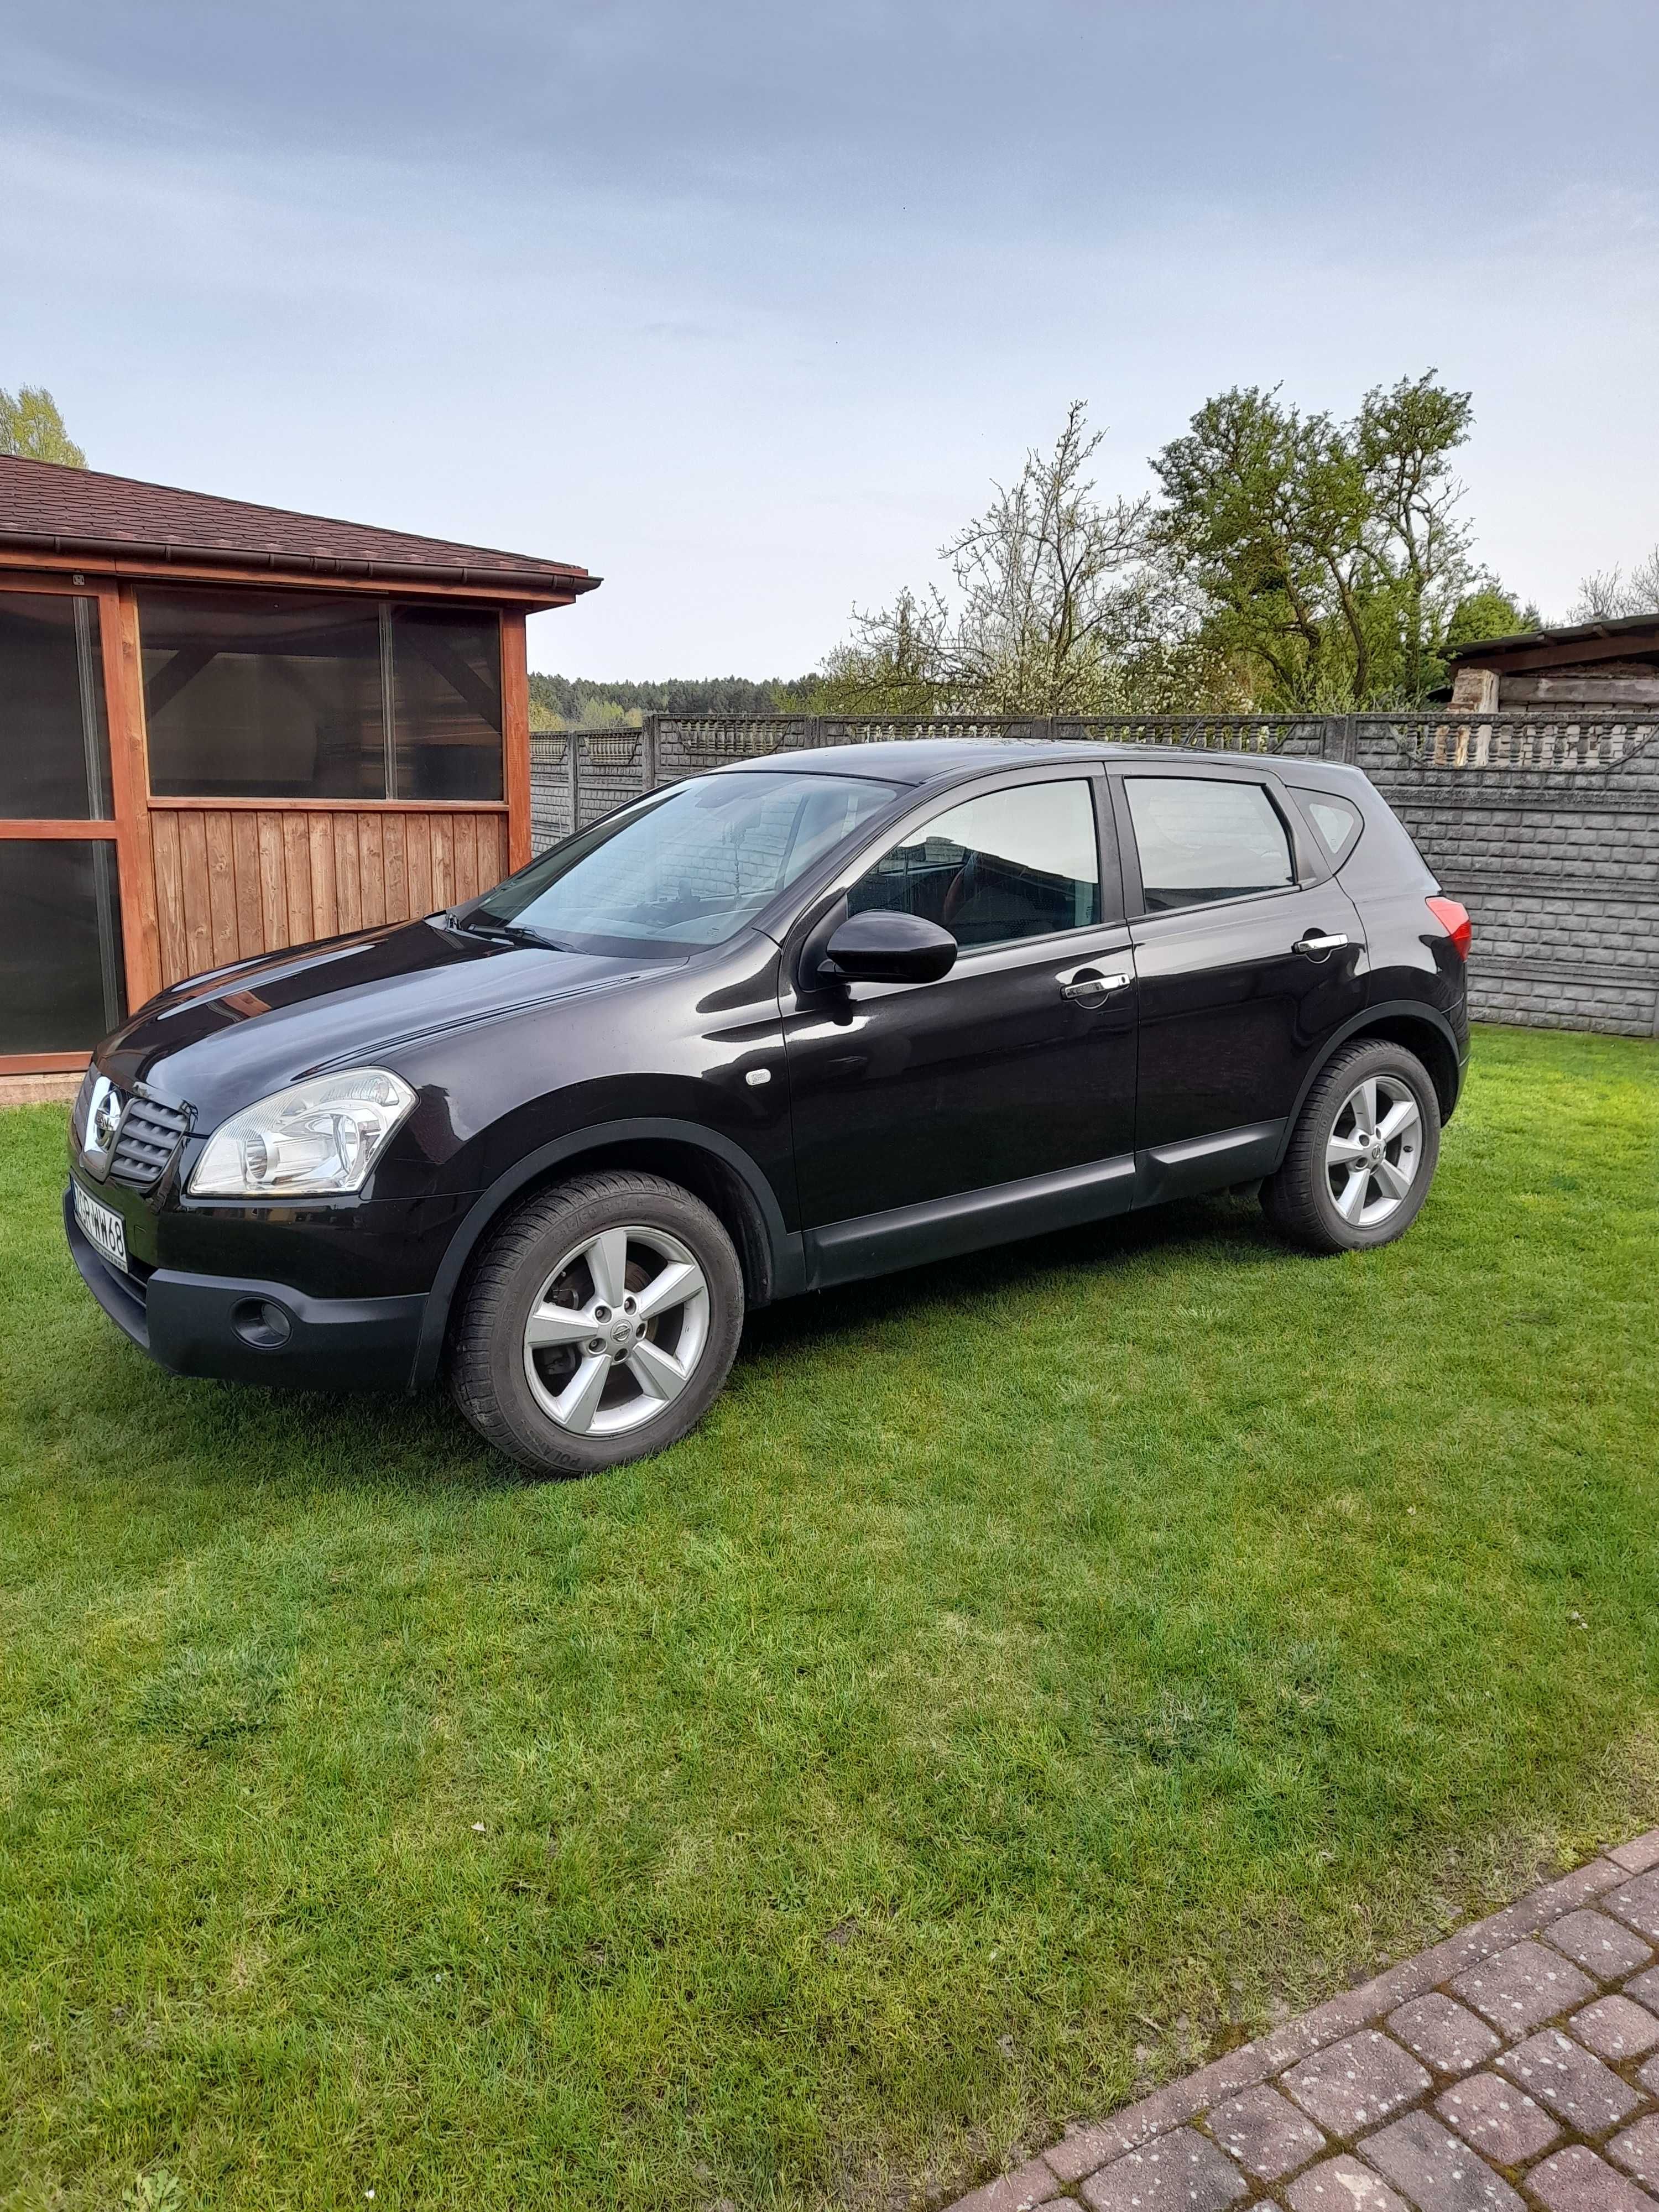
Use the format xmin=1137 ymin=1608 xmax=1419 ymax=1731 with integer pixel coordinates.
xmin=524 ymin=1223 xmax=710 ymax=1436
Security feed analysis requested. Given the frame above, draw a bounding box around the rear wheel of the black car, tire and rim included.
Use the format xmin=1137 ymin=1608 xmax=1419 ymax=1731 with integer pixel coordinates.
xmin=1261 ymin=1037 xmax=1440 ymax=1252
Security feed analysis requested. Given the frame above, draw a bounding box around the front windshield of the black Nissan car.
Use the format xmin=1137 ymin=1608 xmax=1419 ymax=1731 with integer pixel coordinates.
xmin=462 ymin=770 xmax=898 ymax=956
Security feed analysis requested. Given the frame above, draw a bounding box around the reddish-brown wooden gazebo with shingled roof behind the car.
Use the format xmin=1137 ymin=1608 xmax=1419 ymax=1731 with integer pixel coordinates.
xmin=0 ymin=456 xmax=599 ymax=1095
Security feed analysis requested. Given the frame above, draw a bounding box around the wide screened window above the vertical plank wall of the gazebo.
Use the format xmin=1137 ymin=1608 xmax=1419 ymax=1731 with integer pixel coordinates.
xmin=139 ymin=591 xmax=502 ymax=801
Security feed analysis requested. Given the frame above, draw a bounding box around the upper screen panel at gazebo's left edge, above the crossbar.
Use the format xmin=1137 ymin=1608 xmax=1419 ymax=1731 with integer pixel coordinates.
xmin=0 ymin=591 xmax=111 ymax=821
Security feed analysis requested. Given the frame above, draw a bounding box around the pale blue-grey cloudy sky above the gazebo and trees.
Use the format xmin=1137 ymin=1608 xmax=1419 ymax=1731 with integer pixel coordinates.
xmin=0 ymin=0 xmax=1659 ymax=677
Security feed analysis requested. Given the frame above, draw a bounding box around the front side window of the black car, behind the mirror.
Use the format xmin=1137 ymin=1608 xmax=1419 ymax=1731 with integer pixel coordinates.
xmin=847 ymin=779 xmax=1102 ymax=947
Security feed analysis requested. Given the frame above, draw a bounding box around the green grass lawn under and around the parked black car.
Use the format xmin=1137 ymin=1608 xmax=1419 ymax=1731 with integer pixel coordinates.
xmin=0 ymin=1031 xmax=1659 ymax=2212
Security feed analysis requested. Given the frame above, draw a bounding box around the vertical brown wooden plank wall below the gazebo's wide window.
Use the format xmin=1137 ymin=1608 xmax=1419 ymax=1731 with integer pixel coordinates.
xmin=146 ymin=801 xmax=509 ymax=982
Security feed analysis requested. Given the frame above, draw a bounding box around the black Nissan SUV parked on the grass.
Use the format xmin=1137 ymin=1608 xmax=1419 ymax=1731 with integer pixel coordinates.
xmin=64 ymin=739 xmax=1469 ymax=1473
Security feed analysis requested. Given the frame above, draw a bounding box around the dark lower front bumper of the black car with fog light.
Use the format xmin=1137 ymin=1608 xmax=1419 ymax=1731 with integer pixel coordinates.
xmin=64 ymin=1190 xmax=427 ymax=1389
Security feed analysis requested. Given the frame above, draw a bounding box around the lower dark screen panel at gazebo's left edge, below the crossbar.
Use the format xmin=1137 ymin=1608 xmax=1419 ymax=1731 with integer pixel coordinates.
xmin=0 ymin=838 xmax=122 ymax=1053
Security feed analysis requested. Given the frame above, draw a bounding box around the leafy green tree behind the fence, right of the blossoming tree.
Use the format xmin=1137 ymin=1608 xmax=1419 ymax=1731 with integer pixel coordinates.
xmin=1152 ymin=369 xmax=1484 ymax=710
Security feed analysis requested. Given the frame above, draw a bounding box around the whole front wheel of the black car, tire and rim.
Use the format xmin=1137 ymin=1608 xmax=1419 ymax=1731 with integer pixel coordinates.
xmin=449 ymin=1168 xmax=743 ymax=1475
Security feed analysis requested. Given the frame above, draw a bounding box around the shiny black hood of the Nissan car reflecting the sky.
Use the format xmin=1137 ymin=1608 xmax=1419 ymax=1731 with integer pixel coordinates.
xmin=97 ymin=920 xmax=684 ymax=1126
